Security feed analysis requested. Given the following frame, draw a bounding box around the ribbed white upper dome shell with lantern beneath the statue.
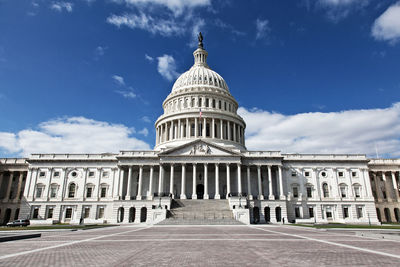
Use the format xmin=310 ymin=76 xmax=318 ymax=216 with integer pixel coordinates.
xmin=172 ymin=47 xmax=229 ymax=93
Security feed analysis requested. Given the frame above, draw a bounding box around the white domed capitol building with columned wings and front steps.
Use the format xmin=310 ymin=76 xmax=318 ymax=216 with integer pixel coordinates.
xmin=0 ymin=37 xmax=400 ymax=224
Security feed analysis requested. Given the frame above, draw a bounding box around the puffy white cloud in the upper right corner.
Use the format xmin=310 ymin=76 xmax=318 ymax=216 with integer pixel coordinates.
xmin=372 ymin=2 xmax=400 ymax=44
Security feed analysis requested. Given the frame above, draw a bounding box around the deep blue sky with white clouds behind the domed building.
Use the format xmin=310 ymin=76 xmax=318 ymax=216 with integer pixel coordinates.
xmin=0 ymin=0 xmax=400 ymax=158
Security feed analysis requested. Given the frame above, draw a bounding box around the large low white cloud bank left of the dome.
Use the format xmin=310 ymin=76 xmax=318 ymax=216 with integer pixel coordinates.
xmin=0 ymin=117 xmax=150 ymax=156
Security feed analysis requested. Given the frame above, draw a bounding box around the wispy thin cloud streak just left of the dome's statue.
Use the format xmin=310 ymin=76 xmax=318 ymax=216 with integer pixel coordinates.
xmin=107 ymin=12 xmax=185 ymax=36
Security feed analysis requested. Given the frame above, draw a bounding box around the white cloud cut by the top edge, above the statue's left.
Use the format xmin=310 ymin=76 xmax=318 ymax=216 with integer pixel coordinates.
xmin=117 ymin=0 xmax=211 ymax=16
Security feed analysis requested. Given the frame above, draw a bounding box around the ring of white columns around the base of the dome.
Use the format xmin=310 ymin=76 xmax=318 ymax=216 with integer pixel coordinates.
xmin=156 ymin=117 xmax=245 ymax=145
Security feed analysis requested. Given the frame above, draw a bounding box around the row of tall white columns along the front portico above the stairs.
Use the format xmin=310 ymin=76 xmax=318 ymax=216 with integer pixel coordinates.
xmin=119 ymin=163 xmax=285 ymax=200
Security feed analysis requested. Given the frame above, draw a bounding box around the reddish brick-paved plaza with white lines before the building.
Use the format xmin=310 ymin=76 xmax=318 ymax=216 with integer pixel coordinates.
xmin=0 ymin=225 xmax=400 ymax=267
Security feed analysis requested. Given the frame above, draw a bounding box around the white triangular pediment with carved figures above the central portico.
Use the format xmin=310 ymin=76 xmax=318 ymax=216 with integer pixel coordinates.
xmin=159 ymin=140 xmax=240 ymax=156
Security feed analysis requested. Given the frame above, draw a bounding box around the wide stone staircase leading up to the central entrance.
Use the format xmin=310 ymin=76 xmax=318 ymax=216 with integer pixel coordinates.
xmin=158 ymin=199 xmax=242 ymax=225
